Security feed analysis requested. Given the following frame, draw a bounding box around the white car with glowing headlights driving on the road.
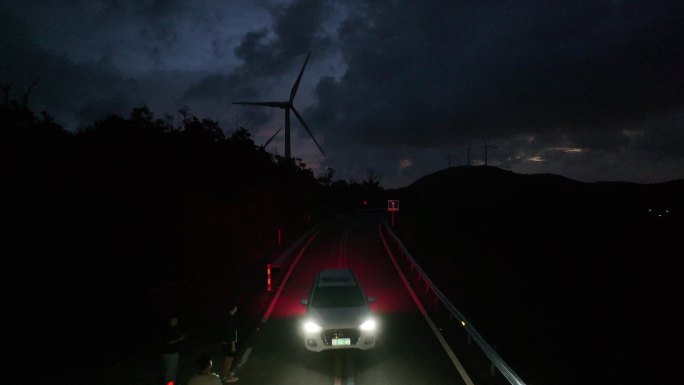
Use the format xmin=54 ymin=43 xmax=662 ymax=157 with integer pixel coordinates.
xmin=301 ymin=269 xmax=378 ymax=352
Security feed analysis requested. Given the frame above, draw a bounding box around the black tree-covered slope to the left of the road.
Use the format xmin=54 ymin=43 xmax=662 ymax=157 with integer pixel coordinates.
xmin=0 ymin=102 xmax=390 ymax=378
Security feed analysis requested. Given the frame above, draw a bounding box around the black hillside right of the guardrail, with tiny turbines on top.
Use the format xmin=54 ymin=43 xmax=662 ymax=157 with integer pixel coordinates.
xmin=389 ymin=166 xmax=684 ymax=384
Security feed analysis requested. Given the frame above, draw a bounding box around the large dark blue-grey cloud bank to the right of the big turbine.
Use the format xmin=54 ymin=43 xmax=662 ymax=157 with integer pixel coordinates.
xmin=317 ymin=1 xmax=684 ymax=147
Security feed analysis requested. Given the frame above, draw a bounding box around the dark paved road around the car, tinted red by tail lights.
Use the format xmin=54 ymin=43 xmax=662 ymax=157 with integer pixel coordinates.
xmin=227 ymin=213 xmax=463 ymax=385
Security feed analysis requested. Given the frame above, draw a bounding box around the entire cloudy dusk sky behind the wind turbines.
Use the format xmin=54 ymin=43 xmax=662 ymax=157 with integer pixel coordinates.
xmin=0 ymin=0 xmax=684 ymax=187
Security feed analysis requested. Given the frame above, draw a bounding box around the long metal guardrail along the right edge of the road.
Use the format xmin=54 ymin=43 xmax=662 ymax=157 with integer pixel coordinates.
xmin=384 ymin=223 xmax=525 ymax=385
